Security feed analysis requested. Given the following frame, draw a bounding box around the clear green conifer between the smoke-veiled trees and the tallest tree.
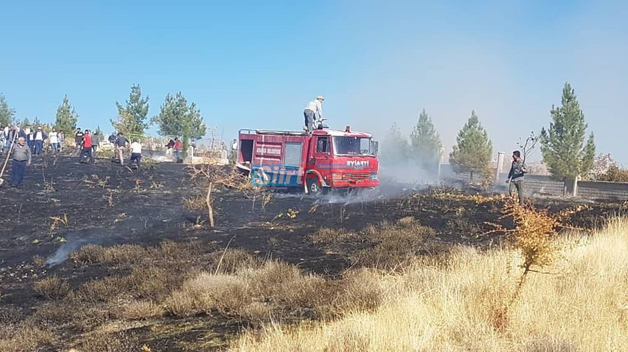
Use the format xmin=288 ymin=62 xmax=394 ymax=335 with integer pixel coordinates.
xmin=449 ymin=111 xmax=493 ymax=179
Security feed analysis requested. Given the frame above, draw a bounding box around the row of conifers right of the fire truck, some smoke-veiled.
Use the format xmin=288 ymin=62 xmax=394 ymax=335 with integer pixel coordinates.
xmin=382 ymin=83 xmax=595 ymax=182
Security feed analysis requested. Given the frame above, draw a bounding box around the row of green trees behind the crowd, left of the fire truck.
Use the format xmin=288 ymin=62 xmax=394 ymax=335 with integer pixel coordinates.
xmin=0 ymin=84 xmax=207 ymax=148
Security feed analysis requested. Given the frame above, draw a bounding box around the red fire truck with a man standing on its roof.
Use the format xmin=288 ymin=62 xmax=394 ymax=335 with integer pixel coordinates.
xmin=236 ymin=126 xmax=379 ymax=194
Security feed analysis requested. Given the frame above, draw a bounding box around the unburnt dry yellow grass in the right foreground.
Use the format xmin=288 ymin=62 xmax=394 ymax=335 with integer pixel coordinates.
xmin=230 ymin=219 xmax=628 ymax=352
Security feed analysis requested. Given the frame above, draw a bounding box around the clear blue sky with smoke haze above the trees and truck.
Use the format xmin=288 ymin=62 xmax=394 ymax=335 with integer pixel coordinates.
xmin=0 ymin=0 xmax=628 ymax=165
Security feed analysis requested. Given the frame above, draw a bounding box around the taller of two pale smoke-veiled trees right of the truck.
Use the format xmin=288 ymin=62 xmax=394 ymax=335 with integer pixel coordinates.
xmin=410 ymin=109 xmax=443 ymax=171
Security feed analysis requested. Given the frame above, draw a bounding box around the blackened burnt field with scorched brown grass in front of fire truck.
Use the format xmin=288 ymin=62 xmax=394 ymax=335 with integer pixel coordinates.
xmin=0 ymin=159 xmax=614 ymax=351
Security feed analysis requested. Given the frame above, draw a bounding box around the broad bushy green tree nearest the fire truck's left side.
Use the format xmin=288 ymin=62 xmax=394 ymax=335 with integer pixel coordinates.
xmin=152 ymin=92 xmax=207 ymax=150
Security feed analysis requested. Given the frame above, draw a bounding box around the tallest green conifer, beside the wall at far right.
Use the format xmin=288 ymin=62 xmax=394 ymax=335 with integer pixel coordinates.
xmin=541 ymin=83 xmax=595 ymax=183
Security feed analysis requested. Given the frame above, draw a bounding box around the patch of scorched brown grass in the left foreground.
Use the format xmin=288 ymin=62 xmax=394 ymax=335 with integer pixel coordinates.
xmin=0 ymin=234 xmax=384 ymax=351
